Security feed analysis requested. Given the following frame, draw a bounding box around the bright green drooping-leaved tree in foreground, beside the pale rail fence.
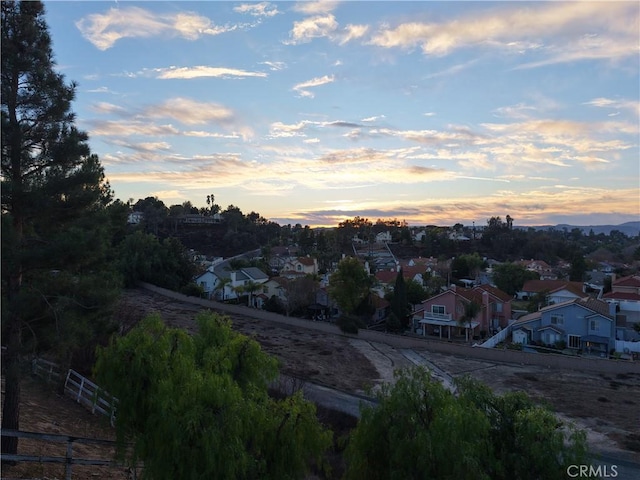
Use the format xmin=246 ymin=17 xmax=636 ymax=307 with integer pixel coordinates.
xmin=95 ymin=312 xmax=331 ymax=480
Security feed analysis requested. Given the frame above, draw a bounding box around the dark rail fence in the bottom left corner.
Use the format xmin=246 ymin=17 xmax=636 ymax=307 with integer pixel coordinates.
xmin=0 ymin=429 xmax=137 ymax=480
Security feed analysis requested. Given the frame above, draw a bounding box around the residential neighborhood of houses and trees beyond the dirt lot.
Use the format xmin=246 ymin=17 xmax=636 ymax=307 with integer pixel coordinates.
xmin=182 ymin=218 xmax=640 ymax=359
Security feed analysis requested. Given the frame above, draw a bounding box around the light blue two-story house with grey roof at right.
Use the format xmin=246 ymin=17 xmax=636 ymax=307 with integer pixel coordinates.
xmin=512 ymin=297 xmax=616 ymax=357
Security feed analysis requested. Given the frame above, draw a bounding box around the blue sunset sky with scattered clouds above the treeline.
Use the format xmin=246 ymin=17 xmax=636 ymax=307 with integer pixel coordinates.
xmin=45 ymin=1 xmax=640 ymax=226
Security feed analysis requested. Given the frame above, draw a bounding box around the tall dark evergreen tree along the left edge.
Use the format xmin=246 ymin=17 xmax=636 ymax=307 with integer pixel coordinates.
xmin=1 ymin=1 xmax=119 ymax=453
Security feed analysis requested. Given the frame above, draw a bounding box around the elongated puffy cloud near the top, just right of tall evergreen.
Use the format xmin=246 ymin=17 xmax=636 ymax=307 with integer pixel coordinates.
xmin=75 ymin=6 xmax=238 ymax=50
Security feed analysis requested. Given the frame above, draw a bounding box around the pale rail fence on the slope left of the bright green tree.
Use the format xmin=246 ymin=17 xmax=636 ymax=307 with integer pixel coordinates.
xmin=31 ymin=358 xmax=118 ymax=426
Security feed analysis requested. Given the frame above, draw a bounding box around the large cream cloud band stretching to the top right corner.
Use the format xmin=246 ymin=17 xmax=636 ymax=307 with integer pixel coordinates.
xmin=368 ymin=2 xmax=638 ymax=67
